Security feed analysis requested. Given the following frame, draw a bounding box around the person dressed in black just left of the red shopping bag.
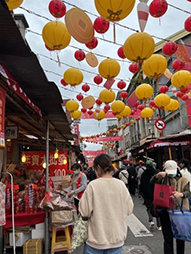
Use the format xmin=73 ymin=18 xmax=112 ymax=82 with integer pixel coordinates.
xmin=140 ymin=160 xmax=162 ymax=230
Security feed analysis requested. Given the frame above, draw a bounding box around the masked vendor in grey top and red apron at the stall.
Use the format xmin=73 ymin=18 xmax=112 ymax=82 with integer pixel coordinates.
xmin=64 ymin=163 xmax=87 ymax=209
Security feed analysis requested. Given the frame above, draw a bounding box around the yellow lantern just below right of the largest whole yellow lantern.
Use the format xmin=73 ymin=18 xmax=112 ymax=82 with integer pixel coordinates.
xmin=142 ymin=54 xmax=167 ymax=80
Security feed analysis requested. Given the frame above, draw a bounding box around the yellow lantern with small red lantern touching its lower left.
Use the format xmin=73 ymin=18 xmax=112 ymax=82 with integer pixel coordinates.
xmin=64 ymin=68 xmax=83 ymax=86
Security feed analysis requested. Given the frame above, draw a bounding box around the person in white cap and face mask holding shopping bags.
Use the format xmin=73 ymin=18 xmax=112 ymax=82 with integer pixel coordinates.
xmin=151 ymin=160 xmax=191 ymax=254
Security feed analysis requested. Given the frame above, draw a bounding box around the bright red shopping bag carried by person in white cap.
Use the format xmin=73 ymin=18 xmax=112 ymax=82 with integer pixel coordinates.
xmin=153 ymin=183 xmax=174 ymax=208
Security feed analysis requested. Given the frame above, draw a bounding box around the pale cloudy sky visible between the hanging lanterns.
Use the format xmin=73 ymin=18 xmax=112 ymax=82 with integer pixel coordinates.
xmin=14 ymin=0 xmax=191 ymax=150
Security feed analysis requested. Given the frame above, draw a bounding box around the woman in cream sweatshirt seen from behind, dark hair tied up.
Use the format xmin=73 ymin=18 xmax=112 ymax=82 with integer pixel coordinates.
xmin=79 ymin=154 xmax=134 ymax=254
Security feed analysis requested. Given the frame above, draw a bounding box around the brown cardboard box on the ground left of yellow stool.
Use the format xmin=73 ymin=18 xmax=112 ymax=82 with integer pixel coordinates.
xmin=23 ymin=239 xmax=44 ymax=254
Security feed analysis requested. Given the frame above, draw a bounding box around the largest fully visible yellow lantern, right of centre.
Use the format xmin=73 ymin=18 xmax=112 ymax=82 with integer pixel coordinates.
xmin=123 ymin=32 xmax=155 ymax=65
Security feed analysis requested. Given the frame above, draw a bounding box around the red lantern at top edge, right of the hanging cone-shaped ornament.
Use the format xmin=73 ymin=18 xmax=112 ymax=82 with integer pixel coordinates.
xmin=149 ymin=0 xmax=168 ymax=18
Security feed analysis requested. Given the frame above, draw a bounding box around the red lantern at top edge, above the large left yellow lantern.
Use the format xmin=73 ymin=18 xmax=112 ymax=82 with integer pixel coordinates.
xmin=48 ymin=0 xmax=66 ymax=18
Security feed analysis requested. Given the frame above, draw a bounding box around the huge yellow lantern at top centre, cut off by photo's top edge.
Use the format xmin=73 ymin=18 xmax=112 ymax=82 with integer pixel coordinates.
xmin=94 ymin=0 xmax=135 ymax=22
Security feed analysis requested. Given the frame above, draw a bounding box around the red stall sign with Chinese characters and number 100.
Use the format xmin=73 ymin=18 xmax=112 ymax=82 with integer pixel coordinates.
xmin=24 ymin=151 xmax=68 ymax=176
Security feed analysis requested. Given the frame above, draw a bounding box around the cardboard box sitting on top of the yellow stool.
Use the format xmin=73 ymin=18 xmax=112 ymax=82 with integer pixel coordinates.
xmin=51 ymin=210 xmax=74 ymax=224
